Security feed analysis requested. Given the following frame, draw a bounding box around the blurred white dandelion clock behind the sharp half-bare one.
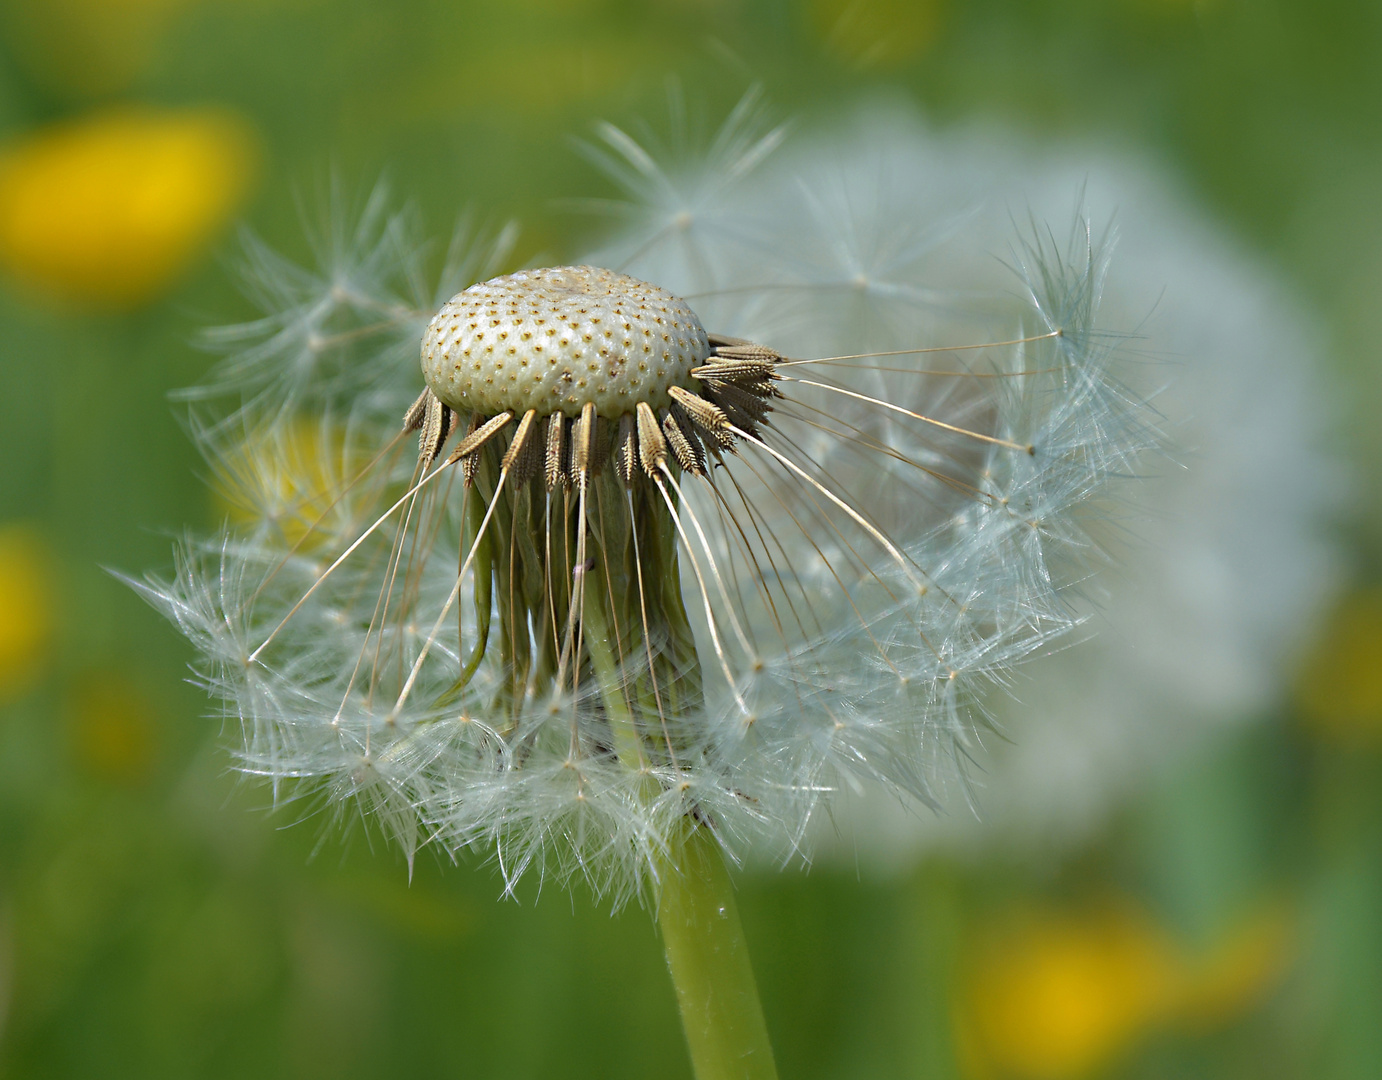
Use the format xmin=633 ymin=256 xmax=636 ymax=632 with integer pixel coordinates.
xmin=594 ymin=104 xmax=1345 ymax=868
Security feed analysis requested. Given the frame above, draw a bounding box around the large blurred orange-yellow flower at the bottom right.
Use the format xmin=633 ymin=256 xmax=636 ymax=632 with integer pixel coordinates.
xmin=955 ymin=903 xmax=1295 ymax=1080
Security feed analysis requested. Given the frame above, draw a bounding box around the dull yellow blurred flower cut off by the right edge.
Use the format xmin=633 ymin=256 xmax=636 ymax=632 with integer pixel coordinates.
xmin=1296 ymin=588 xmax=1382 ymax=745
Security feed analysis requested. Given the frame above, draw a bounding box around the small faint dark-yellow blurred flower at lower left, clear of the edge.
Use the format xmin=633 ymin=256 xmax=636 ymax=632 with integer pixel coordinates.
xmin=68 ymin=672 xmax=155 ymax=784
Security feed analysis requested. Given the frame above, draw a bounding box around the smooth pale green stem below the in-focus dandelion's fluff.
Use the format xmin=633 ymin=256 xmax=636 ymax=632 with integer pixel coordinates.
xmin=658 ymin=827 xmax=777 ymax=1080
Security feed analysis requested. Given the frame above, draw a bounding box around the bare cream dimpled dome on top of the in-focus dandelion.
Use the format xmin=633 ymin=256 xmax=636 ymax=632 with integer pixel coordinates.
xmin=422 ymin=267 xmax=710 ymax=419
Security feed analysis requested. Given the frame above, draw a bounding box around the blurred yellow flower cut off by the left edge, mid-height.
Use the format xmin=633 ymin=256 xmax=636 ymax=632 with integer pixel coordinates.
xmin=0 ymin=523 xmax=54 ymax=701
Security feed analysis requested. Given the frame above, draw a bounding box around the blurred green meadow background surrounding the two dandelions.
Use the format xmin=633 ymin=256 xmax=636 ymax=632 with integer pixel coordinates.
xmin=0 ymin=0 xmax=1382 ymax=1080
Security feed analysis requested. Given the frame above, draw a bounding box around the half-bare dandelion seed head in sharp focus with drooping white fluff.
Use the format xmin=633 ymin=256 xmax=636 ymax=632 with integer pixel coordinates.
xmin=129 ymin=97 xmax=1159 ymax=1074
